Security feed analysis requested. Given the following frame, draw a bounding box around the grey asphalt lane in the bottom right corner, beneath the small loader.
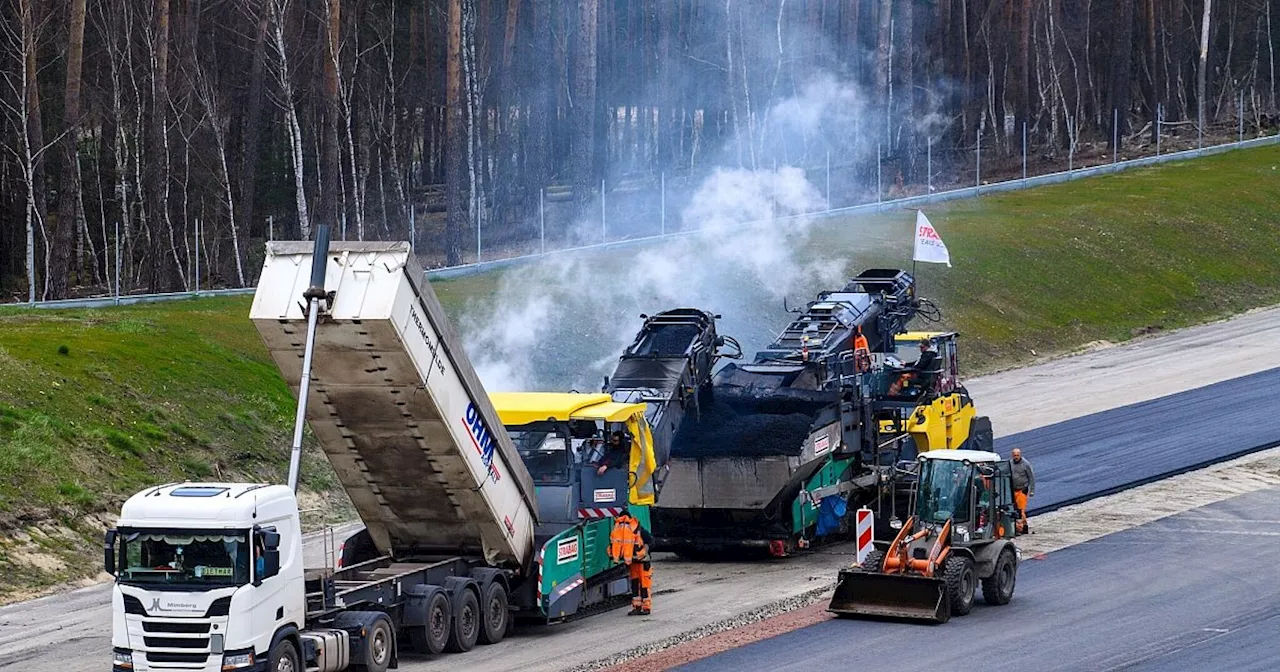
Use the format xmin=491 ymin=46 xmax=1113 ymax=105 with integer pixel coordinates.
xmin=677 ymin=489 xmax=1280 ymax=672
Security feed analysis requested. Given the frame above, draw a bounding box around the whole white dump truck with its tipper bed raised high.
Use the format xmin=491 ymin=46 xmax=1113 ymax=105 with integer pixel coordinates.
xmin=104 ymin=234 xmax=630 ymax=672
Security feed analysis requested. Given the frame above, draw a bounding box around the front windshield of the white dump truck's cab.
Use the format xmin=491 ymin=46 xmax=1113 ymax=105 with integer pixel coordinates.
xmin=119 ymin=530 xmax=248 ymax=589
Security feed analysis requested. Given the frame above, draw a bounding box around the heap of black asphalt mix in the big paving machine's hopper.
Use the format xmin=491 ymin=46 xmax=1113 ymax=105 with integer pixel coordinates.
xmin=671 ymin=402 xmax=813 ymax=457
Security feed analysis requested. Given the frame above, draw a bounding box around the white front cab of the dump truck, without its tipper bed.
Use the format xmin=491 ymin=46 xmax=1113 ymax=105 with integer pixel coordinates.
xmin=104 ymin=483 xmax=306 ymax=672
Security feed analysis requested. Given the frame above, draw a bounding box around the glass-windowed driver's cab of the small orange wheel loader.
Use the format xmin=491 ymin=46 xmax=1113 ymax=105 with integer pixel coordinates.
xmin=911 ymin=451 xmax=1014 ymax=543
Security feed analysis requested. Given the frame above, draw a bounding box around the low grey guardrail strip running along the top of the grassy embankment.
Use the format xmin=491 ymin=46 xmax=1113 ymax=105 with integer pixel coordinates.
xmin=12 ymin=134 xmax=1280 ymax=308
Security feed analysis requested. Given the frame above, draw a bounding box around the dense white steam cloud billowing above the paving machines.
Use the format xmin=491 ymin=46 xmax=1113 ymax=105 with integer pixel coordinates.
xmin=461 ymin=77 xmax=880 ymax=392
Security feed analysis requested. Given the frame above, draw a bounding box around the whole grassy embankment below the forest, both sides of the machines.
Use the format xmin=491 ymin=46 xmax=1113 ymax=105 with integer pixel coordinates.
xmin=0 ymin=147 xmax=1280 ymax=602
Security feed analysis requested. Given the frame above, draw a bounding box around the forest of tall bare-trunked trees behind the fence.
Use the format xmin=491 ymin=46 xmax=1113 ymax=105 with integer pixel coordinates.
xmin=0 ymin=0 xmax=1280 ymax=301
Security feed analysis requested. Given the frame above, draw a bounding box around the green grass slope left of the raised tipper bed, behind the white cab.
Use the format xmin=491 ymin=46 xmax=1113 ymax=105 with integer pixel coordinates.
xmin=0 ymin=298 xmax=345 ymax=599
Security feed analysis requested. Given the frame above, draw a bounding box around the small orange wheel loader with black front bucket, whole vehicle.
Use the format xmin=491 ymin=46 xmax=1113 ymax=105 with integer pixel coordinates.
xmin=828 ymin=451 xmax=1021 ymax=623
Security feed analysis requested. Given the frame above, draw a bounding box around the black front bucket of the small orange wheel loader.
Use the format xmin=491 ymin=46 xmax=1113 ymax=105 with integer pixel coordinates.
xmin=827 ymin=570 xmax=951 ymax=623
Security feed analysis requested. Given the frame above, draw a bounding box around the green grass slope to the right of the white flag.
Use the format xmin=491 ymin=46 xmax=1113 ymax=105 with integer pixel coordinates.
xmin=899 ymin=146 xmax=1280 ymax=369
